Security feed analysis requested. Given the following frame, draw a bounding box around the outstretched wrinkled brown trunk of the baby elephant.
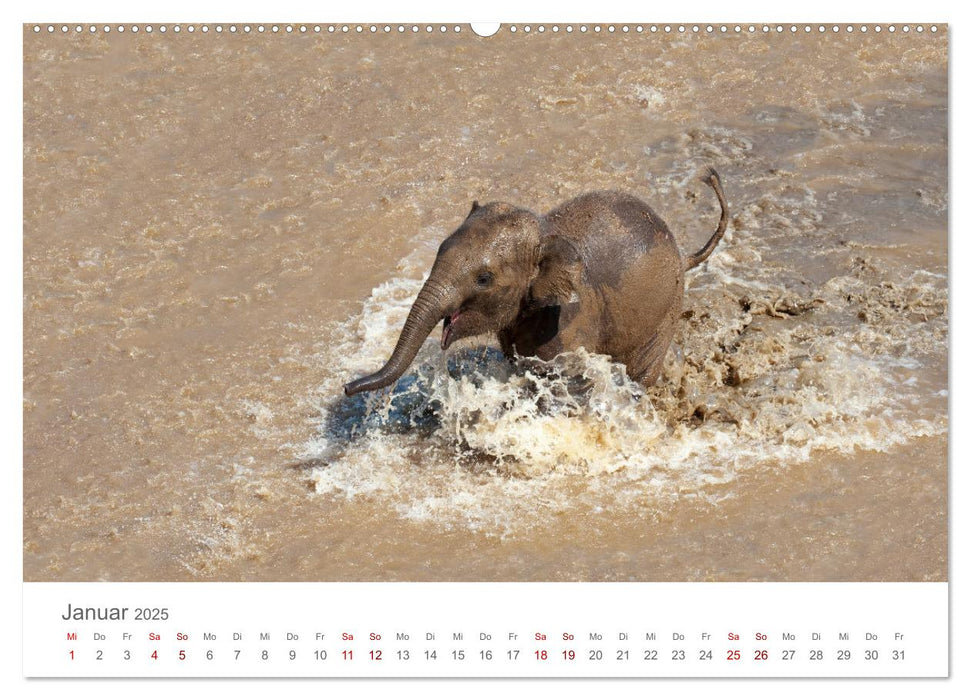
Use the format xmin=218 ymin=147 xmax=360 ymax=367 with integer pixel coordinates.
xmin=344 ymin=275 xmax=450 ymax=396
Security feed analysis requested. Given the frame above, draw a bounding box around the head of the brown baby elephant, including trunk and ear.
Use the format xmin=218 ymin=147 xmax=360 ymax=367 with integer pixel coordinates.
xmin=344 ymin=202 xmax=580 ymax=396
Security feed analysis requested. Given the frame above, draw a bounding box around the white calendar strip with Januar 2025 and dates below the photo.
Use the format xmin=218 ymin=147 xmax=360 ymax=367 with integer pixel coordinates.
xmin=24 ymin=583 xmax=948 ymax=678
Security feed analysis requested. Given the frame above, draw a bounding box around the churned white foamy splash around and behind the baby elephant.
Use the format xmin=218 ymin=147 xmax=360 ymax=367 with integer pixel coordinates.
xmin=301 ymin=219 xmax=947 ymax=534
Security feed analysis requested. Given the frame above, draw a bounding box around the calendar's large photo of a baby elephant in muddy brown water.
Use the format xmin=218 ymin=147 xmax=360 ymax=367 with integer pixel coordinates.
xmin=24 ymin=25 xmax=949 ymax=581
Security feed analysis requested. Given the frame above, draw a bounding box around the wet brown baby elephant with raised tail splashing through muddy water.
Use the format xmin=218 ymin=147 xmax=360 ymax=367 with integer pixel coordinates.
xmin=344 ymin=169 xmax=728 ymax=396
